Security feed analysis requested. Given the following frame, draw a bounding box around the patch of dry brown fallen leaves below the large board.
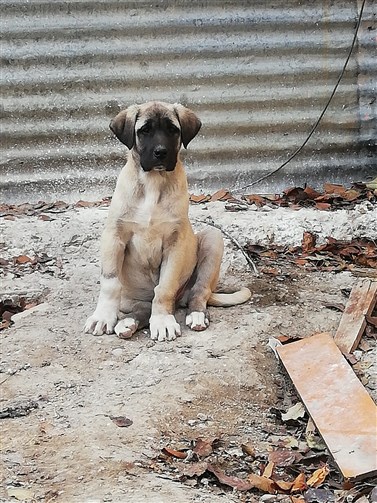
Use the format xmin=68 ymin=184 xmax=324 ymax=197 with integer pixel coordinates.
xmin=149 ymin=432 xmax=330 ymax=502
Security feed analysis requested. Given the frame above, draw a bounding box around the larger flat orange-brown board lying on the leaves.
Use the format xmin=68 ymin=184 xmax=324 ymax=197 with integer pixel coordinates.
xmin=277 ymin=334 xmax=377 ymax=479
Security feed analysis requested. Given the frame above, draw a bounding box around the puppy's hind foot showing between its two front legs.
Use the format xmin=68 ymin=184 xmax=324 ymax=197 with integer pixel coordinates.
xmin=114 ymin=299 xmax=152 ymax=339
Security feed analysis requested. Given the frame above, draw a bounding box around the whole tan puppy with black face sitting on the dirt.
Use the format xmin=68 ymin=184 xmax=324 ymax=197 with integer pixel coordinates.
xmin=85 ymin=102 xmax=250 ymax=341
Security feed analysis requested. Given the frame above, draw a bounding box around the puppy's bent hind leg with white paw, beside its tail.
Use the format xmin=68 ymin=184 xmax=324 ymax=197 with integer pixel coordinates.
xmin=186 ymin=228 xmax=224 ymax=331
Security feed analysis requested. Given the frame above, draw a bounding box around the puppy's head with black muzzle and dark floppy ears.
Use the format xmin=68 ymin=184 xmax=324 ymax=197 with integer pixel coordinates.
xmin=110 ymin=101 xmax=201 ymax=171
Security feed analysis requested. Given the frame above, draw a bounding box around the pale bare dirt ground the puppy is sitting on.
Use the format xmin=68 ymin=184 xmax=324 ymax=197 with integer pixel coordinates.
xmin=0 ymin=199 xmax=377 ymax=503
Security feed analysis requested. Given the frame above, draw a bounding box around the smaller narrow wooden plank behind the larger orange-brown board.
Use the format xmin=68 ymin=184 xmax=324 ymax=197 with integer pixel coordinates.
xmin=334 ymin=279 xmax=377 ymax=353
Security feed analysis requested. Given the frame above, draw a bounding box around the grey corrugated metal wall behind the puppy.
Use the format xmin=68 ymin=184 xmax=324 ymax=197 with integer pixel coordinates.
xmin=0 ymin=0 xmax=376 ymax=202
